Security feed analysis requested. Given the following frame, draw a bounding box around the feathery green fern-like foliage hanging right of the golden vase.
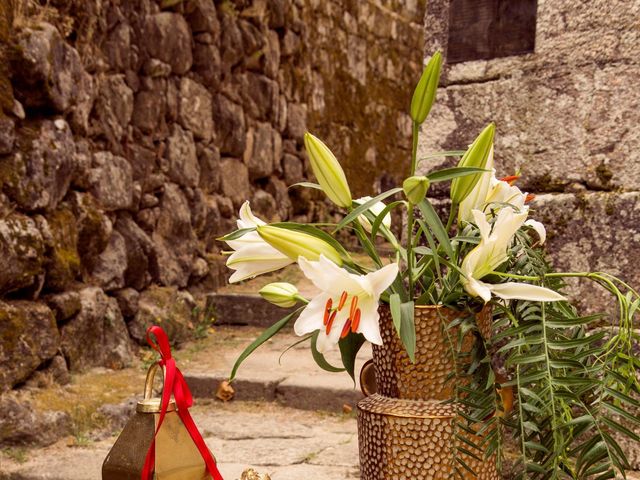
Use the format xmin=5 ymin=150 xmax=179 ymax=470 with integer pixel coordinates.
xmin=450 ymin=228 xmax=640 ymax=479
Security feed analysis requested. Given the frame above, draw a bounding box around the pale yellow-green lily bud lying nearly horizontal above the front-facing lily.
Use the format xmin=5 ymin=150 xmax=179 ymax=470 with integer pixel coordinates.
xmin=256 ymin=225 xmax=342 ymax=265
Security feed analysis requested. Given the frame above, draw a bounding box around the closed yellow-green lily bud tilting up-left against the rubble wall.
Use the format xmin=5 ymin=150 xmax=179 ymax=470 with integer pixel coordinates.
xmin=304 ymin=132 xmax=351 ymax=208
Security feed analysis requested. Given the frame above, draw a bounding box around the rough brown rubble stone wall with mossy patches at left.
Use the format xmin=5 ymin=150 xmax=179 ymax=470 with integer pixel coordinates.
xmin=0 ymin=0 xmax=424 ymax=398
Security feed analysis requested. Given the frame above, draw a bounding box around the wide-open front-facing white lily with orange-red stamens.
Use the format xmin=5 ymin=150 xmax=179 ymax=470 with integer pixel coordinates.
xmin=294 ymin=255 xmax=398 ymax=352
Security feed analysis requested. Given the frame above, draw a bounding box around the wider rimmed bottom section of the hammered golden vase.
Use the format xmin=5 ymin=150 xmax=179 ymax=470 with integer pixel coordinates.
xmin=358 ymin=394 xmax=500 ymax=480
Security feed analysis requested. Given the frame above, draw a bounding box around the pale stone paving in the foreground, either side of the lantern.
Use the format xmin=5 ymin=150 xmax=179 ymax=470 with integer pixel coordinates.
xmin=0 ymin=401 xmax=359 ymax=480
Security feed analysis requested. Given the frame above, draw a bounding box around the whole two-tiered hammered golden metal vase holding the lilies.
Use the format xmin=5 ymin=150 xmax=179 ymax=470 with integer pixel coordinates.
xmin=358 ymin=306 xmax=500 ymax=480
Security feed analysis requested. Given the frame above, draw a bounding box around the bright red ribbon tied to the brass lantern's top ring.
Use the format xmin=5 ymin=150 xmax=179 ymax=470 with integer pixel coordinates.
xmin=142 ymin=325 xmax=224 ymax=480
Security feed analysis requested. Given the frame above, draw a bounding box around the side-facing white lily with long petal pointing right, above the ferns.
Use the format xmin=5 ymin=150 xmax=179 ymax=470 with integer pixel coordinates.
xmin=462 ymin=208 xmax=565 ymax=302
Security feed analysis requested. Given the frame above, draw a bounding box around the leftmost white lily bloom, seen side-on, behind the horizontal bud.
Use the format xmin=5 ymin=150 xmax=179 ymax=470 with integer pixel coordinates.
xmin=227 ymin=202 xmax=294 ymax=283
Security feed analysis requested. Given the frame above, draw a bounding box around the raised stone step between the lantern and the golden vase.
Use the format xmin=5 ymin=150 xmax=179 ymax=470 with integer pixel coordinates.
xmin=177 ymin=327 xmax=371 ymax=412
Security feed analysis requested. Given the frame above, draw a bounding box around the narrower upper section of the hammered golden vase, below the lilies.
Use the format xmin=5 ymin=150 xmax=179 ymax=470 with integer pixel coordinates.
xmin=373 ymin=305 xmax=491 ymax=400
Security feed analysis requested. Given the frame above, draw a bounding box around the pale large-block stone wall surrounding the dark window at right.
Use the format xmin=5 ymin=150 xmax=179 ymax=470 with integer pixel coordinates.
xmin=420 ymin=0 xmax=640 ymax=308
